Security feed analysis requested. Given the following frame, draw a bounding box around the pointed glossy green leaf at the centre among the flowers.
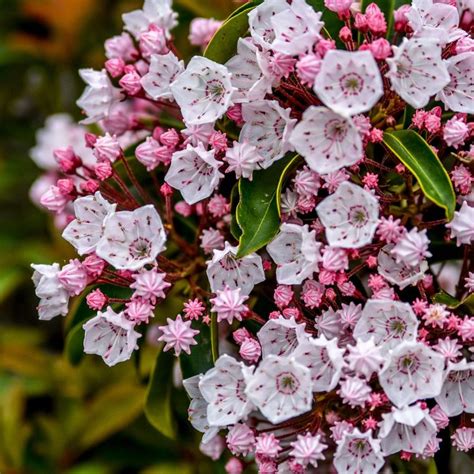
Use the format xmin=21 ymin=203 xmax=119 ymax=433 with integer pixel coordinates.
xmin=236 ymin=155 xmax=299 ymax=258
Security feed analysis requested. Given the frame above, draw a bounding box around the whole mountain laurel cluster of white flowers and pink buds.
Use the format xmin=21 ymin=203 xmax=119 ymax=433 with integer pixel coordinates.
xmin=31 ymin=0 xmax=474 ymax=474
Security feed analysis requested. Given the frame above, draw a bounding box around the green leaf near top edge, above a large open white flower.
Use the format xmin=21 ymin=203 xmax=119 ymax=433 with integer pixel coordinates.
xmin=204 ymin=9 xmax=250 ymax=64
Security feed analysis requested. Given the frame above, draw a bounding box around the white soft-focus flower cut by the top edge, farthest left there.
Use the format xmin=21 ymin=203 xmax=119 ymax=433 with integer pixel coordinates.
xmin=122 ymin=0 xmax=178 ymax=39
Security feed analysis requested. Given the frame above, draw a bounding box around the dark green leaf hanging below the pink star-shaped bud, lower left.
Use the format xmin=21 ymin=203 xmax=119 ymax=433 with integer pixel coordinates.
xmin=145 ymin=350 xmax=176 ymax=439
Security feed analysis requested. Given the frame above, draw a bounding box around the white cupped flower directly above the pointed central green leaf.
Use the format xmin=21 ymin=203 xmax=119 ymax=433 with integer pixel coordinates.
xmin=239 ymin=100 xmax=296 ymax=168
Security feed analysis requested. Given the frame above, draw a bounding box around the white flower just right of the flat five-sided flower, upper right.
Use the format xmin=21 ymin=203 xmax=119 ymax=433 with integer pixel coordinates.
xmin=386 ymin=37 xmax=449 ymax=109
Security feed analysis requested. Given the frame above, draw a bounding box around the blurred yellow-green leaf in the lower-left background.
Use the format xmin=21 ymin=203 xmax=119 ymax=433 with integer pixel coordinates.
xmin=78 ymin=382 xmax=144 ymax=450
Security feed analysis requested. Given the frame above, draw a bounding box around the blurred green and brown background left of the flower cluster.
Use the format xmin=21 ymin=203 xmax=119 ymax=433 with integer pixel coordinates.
xmin=0 ymin=0 xmax=236 ymax=474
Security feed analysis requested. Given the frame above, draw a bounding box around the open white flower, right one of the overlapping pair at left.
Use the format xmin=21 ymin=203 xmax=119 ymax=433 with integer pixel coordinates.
xmin=96 ymin=204 xmax=166 ymax=270
